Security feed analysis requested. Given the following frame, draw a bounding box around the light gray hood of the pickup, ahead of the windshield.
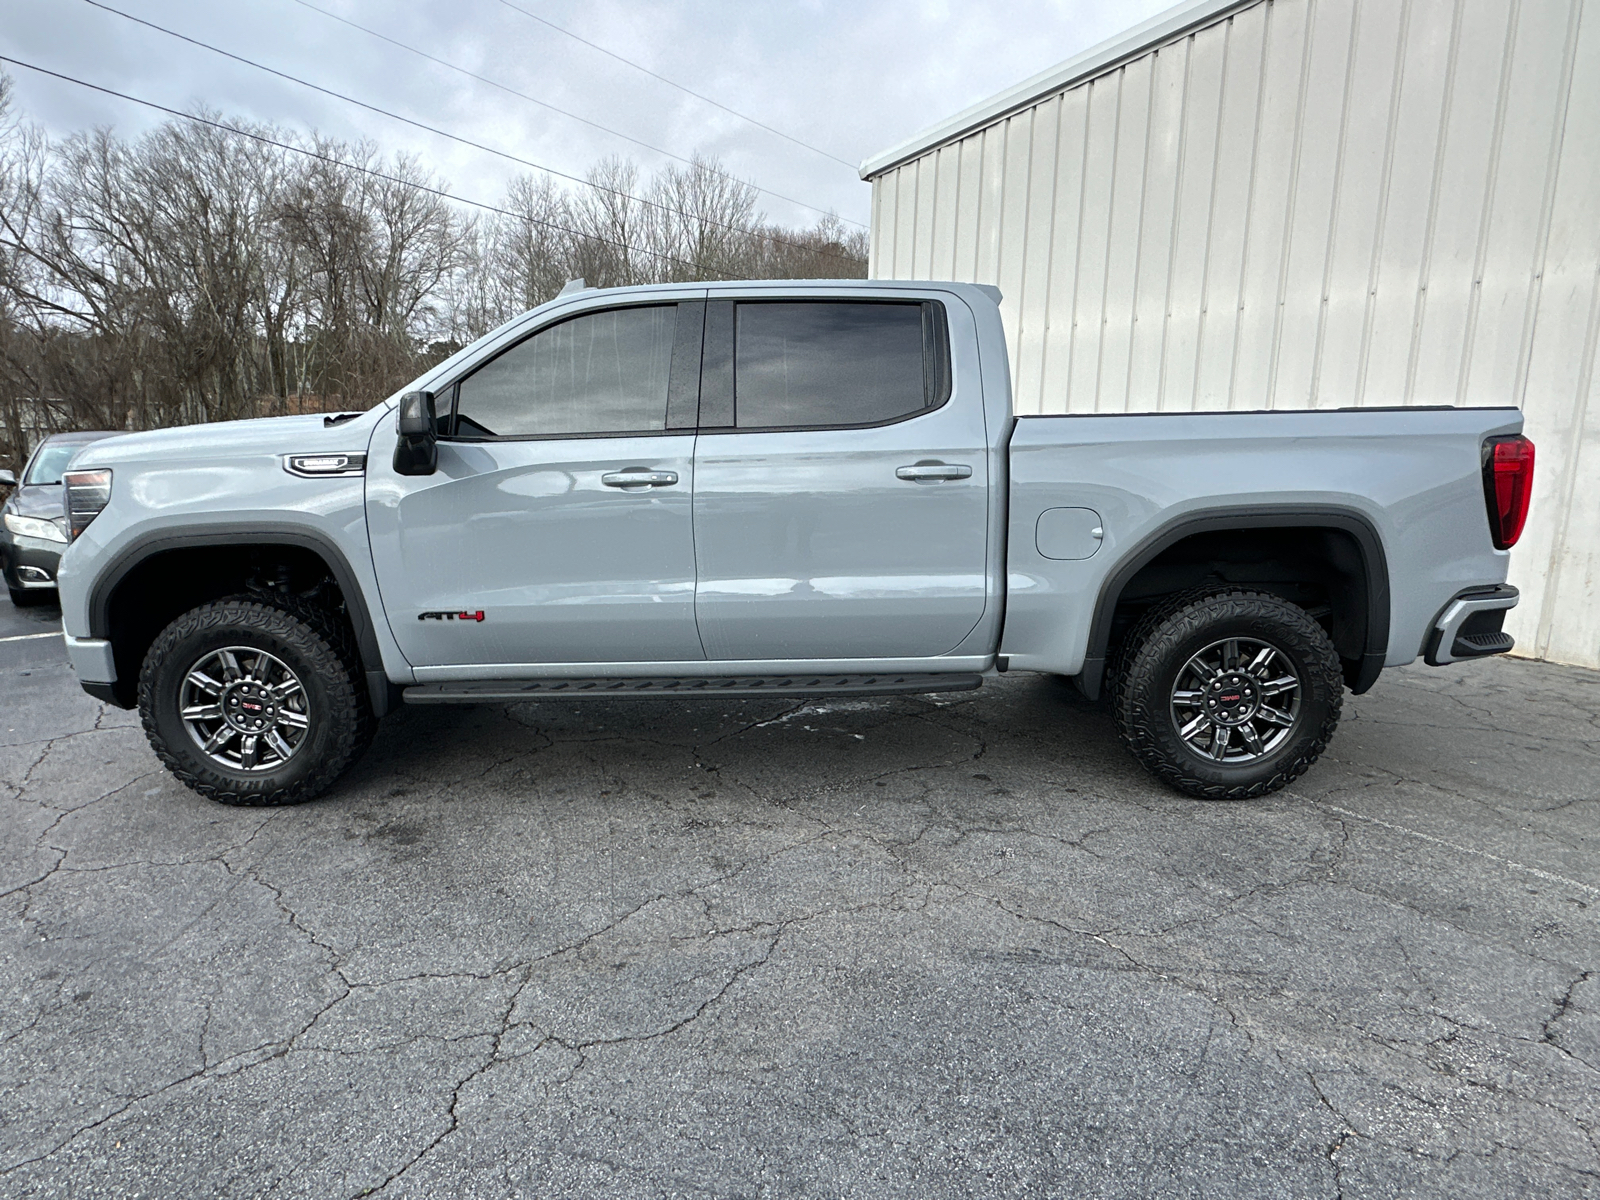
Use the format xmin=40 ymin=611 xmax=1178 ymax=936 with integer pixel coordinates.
xmin=72 ymin=403 xmax=389 ymax=470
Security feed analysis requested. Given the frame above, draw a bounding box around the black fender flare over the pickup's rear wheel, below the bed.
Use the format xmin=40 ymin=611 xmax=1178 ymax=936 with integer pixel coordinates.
xmin=1077 ymin=506 xmax=1390 ymax=699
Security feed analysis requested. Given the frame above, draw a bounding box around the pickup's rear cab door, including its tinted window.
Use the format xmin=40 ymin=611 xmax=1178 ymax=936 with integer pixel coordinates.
xmin=694 ymin=298 xmax=989 ymax=659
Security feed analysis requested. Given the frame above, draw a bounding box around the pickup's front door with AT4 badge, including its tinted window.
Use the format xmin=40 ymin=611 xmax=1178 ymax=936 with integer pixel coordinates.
xmin=368 ymin=302 xmax=704 ymax=667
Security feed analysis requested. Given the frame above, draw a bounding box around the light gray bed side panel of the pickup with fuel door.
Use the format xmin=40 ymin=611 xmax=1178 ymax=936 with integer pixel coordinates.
xmin=1000 ymin=408 xmax=1522 ymax=675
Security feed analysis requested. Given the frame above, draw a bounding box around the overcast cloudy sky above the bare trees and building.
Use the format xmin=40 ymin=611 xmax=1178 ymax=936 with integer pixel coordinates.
xmin=0 ymin=0 xmax=1171 ymax=232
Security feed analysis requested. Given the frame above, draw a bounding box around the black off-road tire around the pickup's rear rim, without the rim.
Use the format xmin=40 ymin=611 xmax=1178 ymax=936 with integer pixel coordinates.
xmin=1112 ymin=589 xmax=1344 ymax=800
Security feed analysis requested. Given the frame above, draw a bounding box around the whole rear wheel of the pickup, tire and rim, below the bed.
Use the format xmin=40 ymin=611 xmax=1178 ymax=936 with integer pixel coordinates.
xmin=1112 ymin=590 xmax=1344 ymax=800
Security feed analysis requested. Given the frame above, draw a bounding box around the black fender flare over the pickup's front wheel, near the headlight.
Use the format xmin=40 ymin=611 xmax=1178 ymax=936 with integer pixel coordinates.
xmin=90 ymin=522 xmax=398 ymax=717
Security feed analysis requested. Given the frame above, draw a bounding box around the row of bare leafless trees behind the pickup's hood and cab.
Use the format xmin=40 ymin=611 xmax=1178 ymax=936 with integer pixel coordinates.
xmin=0 ymin=75 xmax=866 ymax=464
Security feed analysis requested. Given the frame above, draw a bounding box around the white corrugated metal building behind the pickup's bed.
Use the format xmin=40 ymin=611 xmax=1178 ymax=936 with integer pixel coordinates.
xmin=861 ymin=0 xmax=1600 ymax=678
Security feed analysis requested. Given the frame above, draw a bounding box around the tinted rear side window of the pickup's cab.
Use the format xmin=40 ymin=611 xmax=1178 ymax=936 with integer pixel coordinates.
xmin=733 ymin=301 xmax=944 ymax=429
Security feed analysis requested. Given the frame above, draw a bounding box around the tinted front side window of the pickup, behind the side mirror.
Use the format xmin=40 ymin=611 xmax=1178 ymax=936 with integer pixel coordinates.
xmin=456 ymin=304 xmax=677 ymax=438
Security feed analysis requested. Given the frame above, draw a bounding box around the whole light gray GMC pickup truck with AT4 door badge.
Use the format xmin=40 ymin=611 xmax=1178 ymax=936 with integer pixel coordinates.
xmin=50 ymin=280 xmax=1533 ymax=805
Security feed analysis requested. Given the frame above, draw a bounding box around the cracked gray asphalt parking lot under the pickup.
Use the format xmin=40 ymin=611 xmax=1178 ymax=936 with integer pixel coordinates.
xmin=0 ymin=602 xmax=1600 ymax=1197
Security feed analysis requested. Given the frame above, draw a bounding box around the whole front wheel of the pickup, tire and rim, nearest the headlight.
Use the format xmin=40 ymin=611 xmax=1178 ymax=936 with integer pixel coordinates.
xmin=139 ymin=597 xmax=374 ymax=805
